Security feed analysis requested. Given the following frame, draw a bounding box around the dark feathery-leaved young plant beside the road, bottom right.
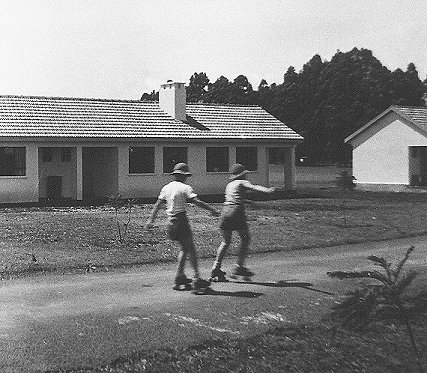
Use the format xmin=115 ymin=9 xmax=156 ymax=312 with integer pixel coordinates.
xmin=327 ymin=246 xmax=427 ymax=372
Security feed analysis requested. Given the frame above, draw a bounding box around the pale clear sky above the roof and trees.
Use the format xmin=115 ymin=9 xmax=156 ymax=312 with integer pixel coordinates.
xmin=0 ymin=0 xmax=427 ymax=100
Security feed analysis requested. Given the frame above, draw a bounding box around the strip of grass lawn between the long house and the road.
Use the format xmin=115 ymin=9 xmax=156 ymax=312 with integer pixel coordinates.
xmin=0 ymin=189 xmax=427 ymax=278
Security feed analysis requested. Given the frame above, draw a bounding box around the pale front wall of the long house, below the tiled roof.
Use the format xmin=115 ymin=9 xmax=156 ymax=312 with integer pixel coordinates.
xmin=0 ymin=140 xmax=295 ymax=203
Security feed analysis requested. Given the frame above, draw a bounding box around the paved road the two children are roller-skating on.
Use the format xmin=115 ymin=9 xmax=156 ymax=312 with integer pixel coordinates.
xmin=0 ymin=236 xmax=427 ymax=373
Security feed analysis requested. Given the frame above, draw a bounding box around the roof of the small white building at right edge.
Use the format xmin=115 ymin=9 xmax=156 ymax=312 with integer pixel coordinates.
xmin=345 ymin=105 xmax=427 ymax=142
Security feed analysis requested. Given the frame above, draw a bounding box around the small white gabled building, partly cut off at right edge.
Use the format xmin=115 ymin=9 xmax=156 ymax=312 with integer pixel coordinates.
xmin=345 ymin=106 xmax=427 ymax=191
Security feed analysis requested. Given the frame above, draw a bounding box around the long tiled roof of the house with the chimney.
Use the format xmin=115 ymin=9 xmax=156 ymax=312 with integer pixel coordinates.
xmin=0 ymin=96 xmax=302 ymax=140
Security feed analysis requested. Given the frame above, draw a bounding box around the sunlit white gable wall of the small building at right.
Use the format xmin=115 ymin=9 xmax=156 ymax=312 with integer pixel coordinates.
xmin=352 ymin=112 xmax=427 ymax=186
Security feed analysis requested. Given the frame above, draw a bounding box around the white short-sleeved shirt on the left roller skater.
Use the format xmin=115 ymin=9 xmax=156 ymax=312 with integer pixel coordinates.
xmin=159 ymin=181 xmax=197 ymax=216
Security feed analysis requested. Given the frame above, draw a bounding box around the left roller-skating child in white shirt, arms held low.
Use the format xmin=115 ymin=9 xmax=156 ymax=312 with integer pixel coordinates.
xmin=146 ymin=163 xmax=219 ymax=292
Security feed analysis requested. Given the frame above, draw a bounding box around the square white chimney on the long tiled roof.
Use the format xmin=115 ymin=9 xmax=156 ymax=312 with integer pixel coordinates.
xmin=159 ymin=80 xmax=187 ymax=121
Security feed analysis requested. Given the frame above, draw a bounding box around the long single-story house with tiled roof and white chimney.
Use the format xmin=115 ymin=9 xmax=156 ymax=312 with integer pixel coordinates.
xmin=0 ymin=82 xmax=302 ymax=203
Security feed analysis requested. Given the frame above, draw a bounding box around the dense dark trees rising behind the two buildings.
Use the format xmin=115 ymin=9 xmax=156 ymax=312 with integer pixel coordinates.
xmin=141 ymin=48 xmax=427 ymax=163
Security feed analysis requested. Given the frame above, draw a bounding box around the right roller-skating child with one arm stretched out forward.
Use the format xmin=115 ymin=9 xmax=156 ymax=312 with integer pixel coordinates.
xmin=211 ymin=163 xmax=275 ymax=281
